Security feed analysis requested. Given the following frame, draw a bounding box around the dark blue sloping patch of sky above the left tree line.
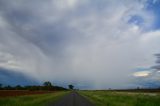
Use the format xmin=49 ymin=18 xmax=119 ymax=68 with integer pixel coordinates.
xmin=0 ymin=68 xmax=39 ymax=86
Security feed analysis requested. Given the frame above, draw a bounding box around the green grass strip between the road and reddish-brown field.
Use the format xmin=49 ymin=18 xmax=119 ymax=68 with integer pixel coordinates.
xmin=0 ymin=91 xmax=68 ymax=106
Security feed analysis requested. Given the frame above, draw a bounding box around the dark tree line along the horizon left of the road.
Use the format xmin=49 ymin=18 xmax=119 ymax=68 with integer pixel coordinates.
xmin=0 ymin=81 xmax=67 ymax=91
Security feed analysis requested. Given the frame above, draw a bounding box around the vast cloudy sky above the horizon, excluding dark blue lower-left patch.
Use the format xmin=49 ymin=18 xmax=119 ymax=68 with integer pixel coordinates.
xmin=0 ymin=0 xmax=160 ymax=89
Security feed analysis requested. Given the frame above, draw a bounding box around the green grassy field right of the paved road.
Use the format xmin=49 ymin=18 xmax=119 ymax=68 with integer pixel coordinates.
xmin=79 ymin=91 xmax=160 ymax=106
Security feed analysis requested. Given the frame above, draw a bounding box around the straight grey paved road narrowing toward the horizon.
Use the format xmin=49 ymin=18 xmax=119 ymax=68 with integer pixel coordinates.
xmin=50 ymin=92 xmax=93 ymax=106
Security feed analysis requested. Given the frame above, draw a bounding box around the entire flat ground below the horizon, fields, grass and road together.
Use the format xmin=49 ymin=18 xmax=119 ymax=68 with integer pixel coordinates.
xmin=0 ymin=90 xmax=160 ymax=106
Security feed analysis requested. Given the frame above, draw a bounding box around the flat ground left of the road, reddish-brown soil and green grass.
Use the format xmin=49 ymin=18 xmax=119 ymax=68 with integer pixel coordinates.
xmin=0 ymin=91 xmax=68 ymax=106
